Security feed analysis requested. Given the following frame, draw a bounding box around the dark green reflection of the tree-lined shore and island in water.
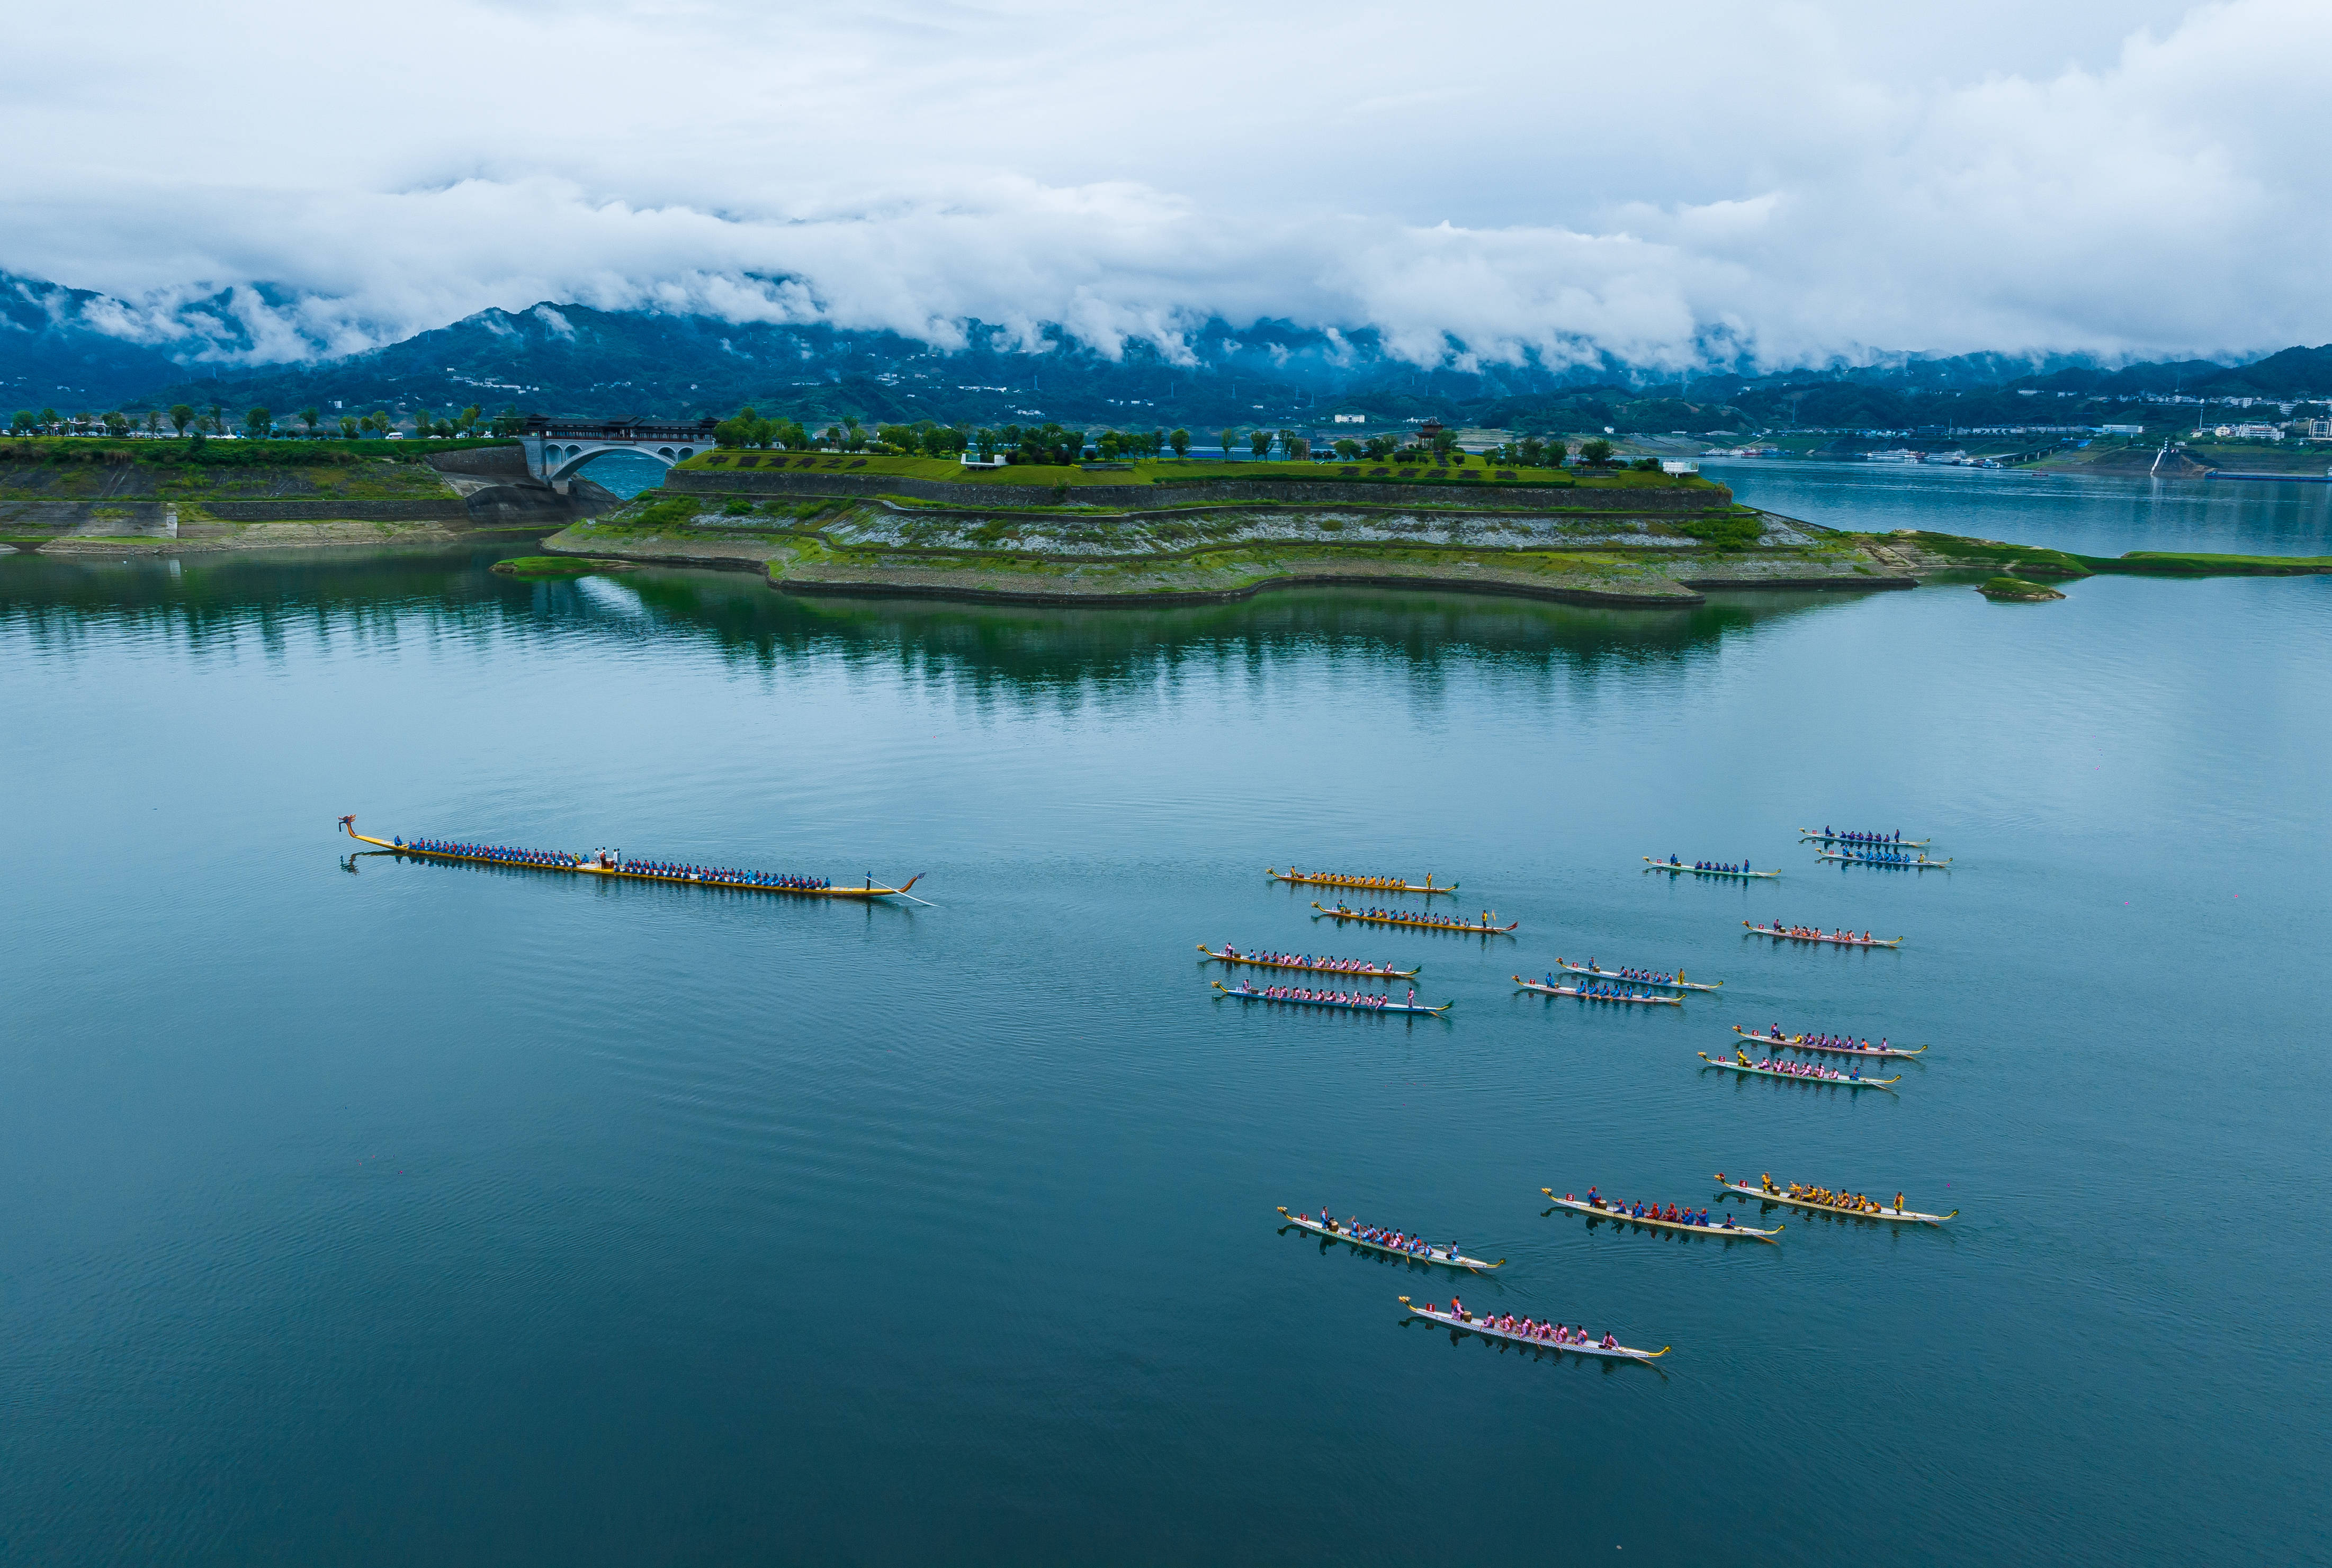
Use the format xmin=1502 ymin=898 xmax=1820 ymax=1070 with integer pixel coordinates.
xmin=0 ymin=547 xmax=1845 ymax=687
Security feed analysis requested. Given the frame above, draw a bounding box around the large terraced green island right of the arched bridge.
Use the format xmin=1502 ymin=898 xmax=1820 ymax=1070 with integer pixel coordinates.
xmin=543 ymin=449 xmax=1912 ymax=606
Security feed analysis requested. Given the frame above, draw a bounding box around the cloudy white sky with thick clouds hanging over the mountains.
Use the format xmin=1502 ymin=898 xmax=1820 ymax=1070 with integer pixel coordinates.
xmin=0 ymin=0 xmax=2332 ymax=368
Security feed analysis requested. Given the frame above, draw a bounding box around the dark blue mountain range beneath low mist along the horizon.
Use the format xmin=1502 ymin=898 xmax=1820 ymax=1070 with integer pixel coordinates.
xmin=13 ymin=273 xmax=2332 ymax=434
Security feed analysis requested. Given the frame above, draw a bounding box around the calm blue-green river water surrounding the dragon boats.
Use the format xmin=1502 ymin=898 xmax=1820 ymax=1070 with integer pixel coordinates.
xmin=0 ymin=464 xmax=2332 ymax=1566
